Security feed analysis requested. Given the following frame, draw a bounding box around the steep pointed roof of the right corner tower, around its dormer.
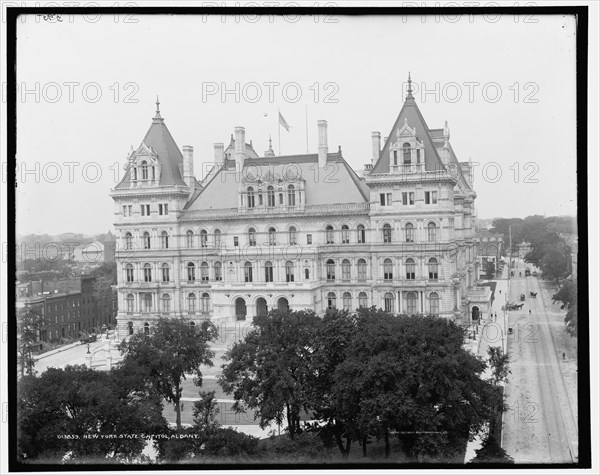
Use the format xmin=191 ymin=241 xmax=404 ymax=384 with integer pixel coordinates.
xmin=371 ymin=93 xmax=442 ymax=173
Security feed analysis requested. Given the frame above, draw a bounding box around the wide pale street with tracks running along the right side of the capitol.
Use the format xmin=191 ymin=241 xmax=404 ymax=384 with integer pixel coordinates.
xmin=503 ymin=261 xmax=578 ymax=463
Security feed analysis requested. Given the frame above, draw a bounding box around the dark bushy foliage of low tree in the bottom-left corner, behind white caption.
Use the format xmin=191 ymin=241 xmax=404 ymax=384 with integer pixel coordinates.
xmin=17 ymin=365 xmax=167 ymax=461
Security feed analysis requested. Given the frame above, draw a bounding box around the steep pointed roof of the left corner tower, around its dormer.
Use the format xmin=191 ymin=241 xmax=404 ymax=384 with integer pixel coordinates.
xmin=116 ymin=102 xmax=186 ymax=189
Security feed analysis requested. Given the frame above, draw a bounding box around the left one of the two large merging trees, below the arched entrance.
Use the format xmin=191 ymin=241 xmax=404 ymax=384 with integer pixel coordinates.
xmin=219 ymin=310 xmax=321 ymax=439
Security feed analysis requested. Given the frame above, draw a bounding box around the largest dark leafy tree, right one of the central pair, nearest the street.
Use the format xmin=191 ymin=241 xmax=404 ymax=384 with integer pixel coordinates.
xmin=333 ymin=309 xmax=501 ymax=457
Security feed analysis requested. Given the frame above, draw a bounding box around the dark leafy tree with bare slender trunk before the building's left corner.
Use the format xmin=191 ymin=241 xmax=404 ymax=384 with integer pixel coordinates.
xmin=120 ymin=317 xmax=217 ymax=431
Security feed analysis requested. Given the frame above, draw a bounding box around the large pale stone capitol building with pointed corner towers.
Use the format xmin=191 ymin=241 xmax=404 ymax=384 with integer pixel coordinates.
xmin=111 ymin=79 xmax=478 ymax=337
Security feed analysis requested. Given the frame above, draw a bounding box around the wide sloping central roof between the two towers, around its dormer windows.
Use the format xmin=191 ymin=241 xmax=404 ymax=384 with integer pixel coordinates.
xmin=186 ymin=152 xmax=369 ymax=210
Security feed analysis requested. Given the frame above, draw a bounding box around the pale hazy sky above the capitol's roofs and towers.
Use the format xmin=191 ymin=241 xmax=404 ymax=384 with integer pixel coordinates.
xmin=17 ymin=10 xmax=577 ymax=234
